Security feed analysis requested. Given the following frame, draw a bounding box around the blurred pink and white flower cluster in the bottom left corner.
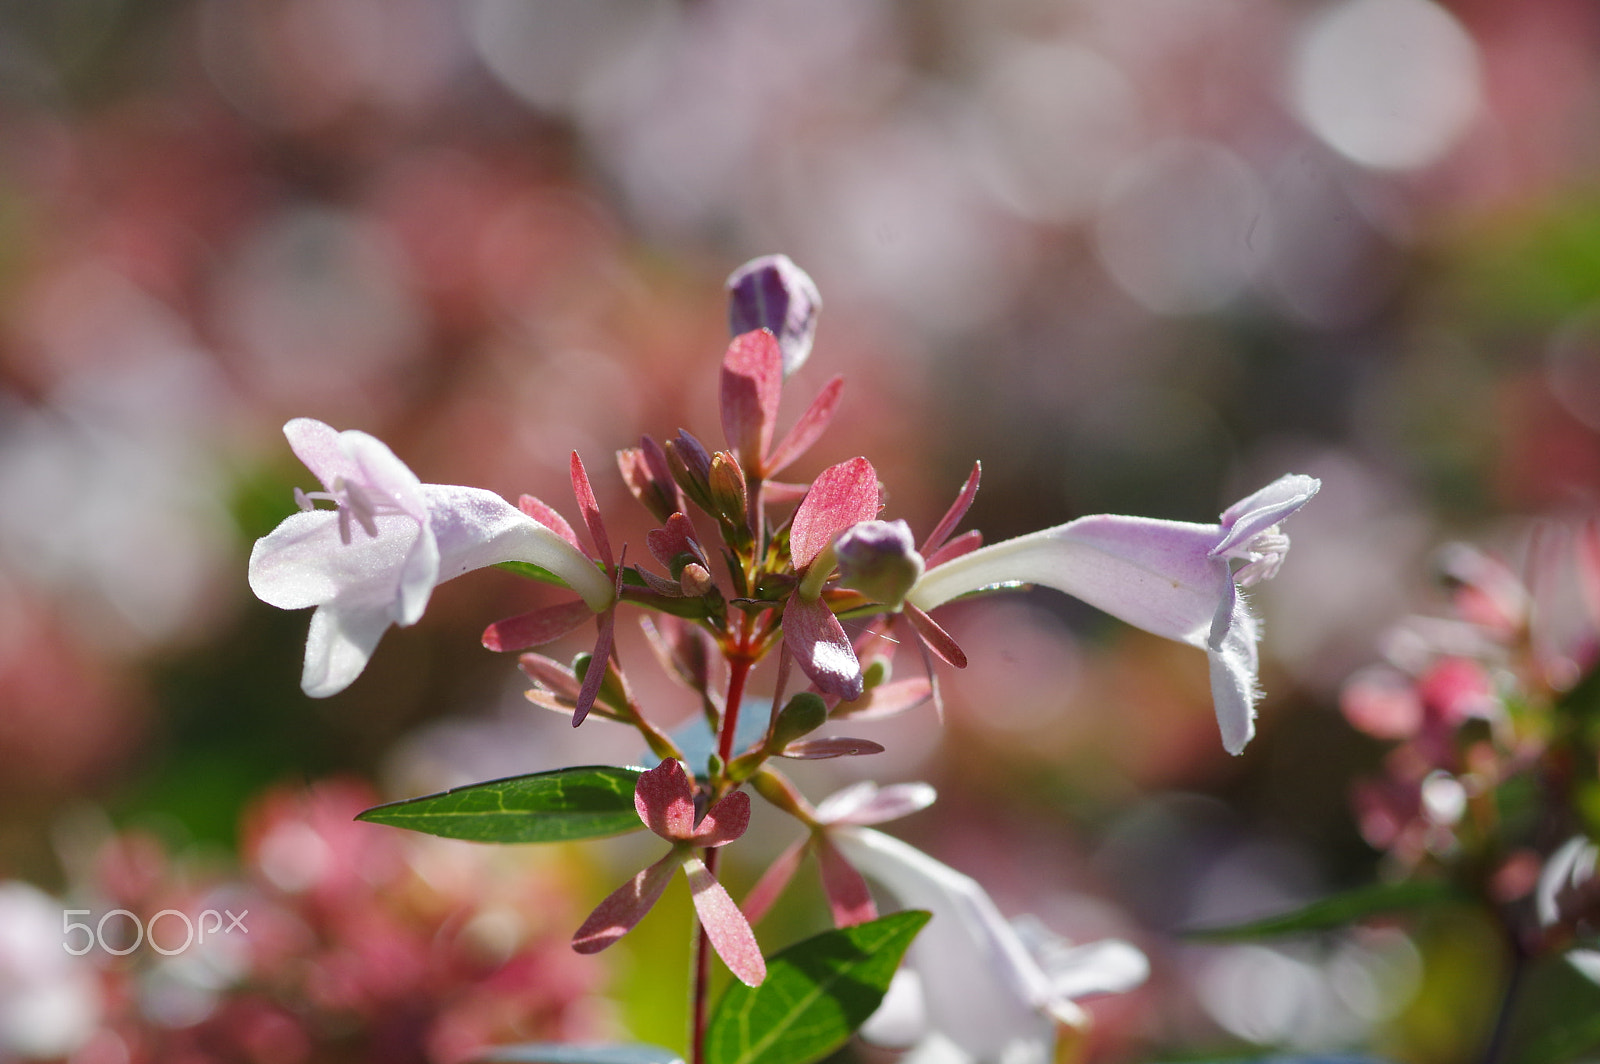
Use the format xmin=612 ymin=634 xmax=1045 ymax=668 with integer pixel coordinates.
xmin=0 ymin=781 xmax=602 ymax=1064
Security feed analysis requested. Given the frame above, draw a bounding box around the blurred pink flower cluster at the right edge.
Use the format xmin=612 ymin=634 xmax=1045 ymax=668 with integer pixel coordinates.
xmin=1341 ymin=520 xmax=1600 ymax=976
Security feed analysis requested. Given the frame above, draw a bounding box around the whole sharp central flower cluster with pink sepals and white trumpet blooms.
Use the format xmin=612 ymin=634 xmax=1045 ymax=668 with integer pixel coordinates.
xmin=250 ymin=256 xmax=1318 ymax=1059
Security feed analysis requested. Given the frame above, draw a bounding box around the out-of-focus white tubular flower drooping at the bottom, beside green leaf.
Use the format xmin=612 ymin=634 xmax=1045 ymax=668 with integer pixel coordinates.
xmin=830 ymin=827 xmax=1149 ymax=1064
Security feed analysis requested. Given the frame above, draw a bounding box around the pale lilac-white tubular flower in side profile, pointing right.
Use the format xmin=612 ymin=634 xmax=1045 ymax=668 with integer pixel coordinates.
xmin=907 ymin=474 xmax=1322 ymax=754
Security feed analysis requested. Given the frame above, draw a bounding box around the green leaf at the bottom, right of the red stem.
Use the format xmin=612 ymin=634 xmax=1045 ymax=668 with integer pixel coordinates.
xmin=706 ymin=909 xmax=930 ymax=1064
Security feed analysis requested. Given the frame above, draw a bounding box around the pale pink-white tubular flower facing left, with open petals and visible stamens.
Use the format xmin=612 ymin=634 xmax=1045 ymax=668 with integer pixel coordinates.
xmin=250 ymin=418 xmax=613 ymax=698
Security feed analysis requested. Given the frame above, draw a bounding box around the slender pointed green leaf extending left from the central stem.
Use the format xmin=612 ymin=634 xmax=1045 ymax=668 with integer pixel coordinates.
xmin=355 ymin=765 xmax=643 ymax=842
